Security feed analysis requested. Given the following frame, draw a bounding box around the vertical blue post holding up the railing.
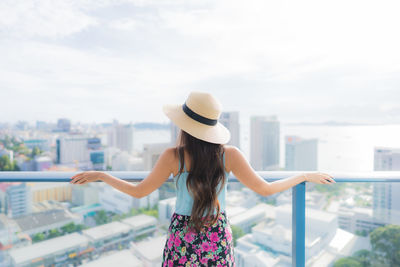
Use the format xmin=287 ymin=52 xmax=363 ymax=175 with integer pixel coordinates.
xmin=292 ymin=182 xmax=306 ymax=267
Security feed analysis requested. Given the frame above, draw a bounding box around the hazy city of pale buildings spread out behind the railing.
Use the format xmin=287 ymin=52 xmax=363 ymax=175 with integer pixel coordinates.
xmin=0 ymin=115 xmax=400 ymax=267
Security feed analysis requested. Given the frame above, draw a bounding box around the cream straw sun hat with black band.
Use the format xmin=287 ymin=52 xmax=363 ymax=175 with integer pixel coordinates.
xmin=163 ymin=92 xmax=231 ymax=144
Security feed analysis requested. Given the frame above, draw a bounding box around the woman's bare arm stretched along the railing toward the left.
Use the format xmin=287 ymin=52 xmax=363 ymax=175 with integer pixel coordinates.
xmin=71 ymin=148 xmax=174 ymax=198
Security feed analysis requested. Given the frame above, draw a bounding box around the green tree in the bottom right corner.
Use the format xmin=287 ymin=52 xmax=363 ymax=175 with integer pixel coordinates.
xmin=370 ymin=225 xmax=400 ymax=266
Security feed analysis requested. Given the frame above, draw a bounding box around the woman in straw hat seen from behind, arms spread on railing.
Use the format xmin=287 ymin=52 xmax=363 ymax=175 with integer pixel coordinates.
xmin=71 ymin=92 xmax=335 ymax=266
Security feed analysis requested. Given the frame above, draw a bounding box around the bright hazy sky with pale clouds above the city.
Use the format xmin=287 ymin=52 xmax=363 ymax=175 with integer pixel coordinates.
xmin=0 ymin=0 xmax=400 ymax=124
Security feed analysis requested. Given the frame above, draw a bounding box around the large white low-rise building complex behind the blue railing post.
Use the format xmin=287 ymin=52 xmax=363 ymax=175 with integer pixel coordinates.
xmin=235 ymin=205 xmax=346 ymax=266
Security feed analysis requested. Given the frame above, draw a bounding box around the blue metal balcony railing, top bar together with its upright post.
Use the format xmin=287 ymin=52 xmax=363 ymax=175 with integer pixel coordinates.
xmin=0 ymin=171 xmax=400 ymax=267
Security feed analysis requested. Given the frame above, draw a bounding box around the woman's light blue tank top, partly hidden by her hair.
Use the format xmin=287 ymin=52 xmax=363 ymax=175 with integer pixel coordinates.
xmin=173 ymin=151 xmax=229 ymax=216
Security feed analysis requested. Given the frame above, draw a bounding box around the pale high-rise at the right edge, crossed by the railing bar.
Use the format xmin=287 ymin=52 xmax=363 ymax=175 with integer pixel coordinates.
xmin=373 ymin=147 xmax=400 ymax=224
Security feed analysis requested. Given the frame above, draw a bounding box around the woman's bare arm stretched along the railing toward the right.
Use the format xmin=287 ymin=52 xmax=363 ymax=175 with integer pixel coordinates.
xmin=229 ymin=146 xmax=335 ymax=196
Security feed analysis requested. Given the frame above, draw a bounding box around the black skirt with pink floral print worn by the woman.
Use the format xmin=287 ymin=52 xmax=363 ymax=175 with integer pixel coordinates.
xmin=162 ymin=211 xmax=235 ymax=267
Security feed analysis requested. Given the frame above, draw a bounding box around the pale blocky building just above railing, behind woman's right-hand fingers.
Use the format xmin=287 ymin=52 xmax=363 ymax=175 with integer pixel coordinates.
xmin=285 ymin=135 xmax=318 ymax=171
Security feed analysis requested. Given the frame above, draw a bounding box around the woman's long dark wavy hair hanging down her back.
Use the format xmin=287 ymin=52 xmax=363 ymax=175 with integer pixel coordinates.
xmin=176 ymin=130 xmax=226 ymax=232
